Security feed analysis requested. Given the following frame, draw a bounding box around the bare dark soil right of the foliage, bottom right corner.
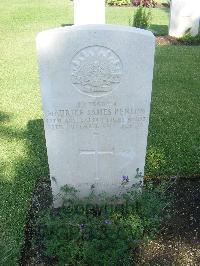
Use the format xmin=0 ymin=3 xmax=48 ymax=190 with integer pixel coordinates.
xmin=135 ymin=179 xmax=200 ymax=266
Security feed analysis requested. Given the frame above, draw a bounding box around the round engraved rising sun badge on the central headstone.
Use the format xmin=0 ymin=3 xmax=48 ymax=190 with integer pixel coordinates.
xmin=71 ymin=46 xmax=122 ymax=96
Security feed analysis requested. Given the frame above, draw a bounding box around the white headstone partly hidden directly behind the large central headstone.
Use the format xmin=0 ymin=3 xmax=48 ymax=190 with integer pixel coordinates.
xmin=74 ymin=0 xmax=105 ymax=25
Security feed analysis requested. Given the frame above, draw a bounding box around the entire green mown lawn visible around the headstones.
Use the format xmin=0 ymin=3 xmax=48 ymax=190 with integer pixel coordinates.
xmin=0 ymin=0 xmax=200 ymax=266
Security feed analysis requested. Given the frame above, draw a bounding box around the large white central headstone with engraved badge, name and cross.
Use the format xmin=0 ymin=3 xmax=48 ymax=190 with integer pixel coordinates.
xmin=37 ymin=25 xmax=155 ymax=207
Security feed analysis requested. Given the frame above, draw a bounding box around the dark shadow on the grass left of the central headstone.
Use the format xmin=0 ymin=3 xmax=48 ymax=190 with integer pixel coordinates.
xmin=0 ymin=119 xmax=49 ymax=265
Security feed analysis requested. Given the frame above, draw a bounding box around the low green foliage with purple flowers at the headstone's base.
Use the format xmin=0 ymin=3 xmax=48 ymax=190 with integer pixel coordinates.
xmin=35 ymin=185 xmax=167 ymax=266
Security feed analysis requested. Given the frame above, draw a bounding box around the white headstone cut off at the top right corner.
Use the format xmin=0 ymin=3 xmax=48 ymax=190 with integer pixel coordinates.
xmin=169 ymin=0 xmax=200 ymax=37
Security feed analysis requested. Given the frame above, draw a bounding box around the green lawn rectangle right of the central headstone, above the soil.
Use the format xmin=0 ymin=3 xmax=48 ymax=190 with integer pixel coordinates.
xmin=146 ymin=46 xmax=200 ymax=176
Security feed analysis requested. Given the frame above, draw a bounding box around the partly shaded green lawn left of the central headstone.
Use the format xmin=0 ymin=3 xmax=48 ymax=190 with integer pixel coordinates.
xmin=0 ymin=0 xmax=72 ymax=266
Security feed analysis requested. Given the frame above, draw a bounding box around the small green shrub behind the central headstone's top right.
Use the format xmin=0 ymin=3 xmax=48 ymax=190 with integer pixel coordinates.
xmin=132 ymin=6 xmax=151 ymax=29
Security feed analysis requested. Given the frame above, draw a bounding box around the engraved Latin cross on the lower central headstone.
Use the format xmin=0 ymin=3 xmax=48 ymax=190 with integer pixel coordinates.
xmin=79 ymin=133 xmax=114 ymax=180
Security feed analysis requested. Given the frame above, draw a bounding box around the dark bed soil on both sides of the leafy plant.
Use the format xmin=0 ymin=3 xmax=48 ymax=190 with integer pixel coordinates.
xmin=20 ymin=178 xmax=200 ymax=266
